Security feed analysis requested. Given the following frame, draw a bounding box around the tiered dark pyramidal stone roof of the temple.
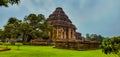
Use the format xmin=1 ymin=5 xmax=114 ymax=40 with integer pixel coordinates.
xmin=48 ymin=7 xmax=76 ymax=29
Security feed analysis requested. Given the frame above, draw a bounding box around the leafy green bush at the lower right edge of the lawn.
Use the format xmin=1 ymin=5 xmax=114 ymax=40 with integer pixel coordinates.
xmin=102 ymin=36 xmax=120 ymax=56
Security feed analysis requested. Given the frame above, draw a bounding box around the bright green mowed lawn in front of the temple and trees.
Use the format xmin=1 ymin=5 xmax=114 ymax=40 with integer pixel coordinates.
xmin=0 ymin=46 xmax=117 ymax=57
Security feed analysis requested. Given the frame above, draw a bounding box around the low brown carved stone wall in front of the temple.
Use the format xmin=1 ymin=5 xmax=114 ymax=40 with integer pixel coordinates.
xmin=55 ymin=40 xmax=100 ymax=50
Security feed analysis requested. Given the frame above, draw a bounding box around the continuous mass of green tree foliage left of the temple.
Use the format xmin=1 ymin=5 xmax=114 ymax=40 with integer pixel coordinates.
xmin=0 ymin=14 xmax=53 ymax=42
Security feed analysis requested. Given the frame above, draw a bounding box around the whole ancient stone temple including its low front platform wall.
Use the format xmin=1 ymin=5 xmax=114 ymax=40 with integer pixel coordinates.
xmin=48 ymin=7 xmax=100 ymax=50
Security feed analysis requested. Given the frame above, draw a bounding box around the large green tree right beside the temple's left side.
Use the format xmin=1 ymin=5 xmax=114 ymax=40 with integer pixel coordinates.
xmin=24 ymin=14 xmax=53 ymax=41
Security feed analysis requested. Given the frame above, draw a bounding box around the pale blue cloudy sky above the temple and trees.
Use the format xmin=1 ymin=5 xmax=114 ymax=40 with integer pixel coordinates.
xmin=0 ymin=0 xmax=120 ymax=37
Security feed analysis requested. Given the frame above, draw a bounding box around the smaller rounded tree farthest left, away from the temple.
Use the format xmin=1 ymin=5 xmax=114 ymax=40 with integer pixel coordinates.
xmin=4 ymin=17 xmax=21 ymax=38
